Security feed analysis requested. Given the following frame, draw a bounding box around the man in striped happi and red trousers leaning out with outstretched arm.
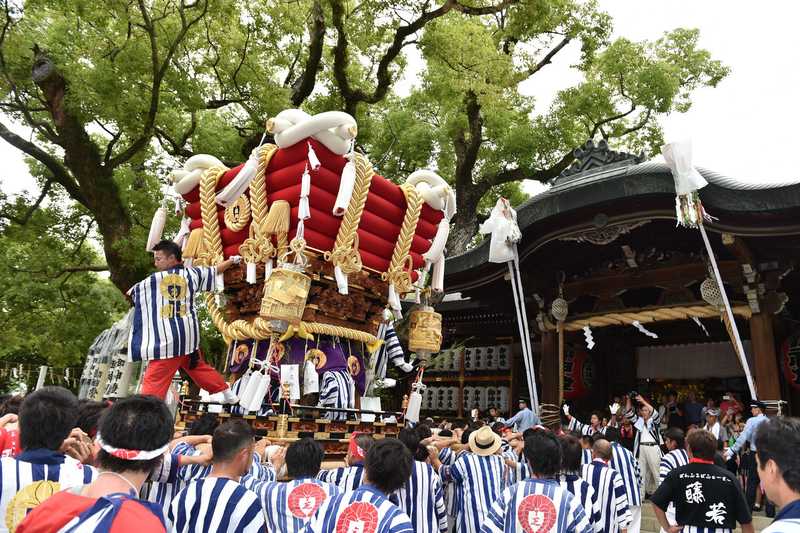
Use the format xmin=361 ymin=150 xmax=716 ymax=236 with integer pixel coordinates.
xmin=128 ymin=241 xmax=239 ymax=403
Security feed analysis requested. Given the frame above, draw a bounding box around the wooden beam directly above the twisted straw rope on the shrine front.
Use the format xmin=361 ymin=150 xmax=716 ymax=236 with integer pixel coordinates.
xmin=564 ymin=261 xmax=743 ymax=300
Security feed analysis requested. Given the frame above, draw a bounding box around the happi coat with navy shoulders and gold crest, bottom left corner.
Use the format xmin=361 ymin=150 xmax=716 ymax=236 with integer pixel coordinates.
xmin=0 ymin=449 xmax=97 ymax=533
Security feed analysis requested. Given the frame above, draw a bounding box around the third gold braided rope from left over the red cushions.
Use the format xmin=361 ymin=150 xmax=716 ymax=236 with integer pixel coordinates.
xmin=325 ymin=154 xmax=375 ymax=274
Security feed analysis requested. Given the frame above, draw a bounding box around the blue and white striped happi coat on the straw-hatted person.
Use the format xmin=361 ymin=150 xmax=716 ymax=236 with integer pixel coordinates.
xmin=439 ymin=453 xmax=506 ymax=533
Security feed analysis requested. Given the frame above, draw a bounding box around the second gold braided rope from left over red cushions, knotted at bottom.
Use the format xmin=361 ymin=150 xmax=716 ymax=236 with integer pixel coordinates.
xmin=239 ymin=144 xmax=278 ymax=263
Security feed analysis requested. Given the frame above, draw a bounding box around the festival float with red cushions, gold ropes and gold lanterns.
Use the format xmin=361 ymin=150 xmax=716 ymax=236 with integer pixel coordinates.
xmin=153 ymin=109 xmax=455 ymax=455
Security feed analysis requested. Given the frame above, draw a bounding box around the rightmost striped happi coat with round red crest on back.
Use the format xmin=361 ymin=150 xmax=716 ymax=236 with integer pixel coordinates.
xmin=480 ymin=479 xmax=594 ymax=533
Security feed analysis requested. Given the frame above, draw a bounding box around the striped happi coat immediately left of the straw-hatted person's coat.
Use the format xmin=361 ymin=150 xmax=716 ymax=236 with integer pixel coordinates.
xmin=389 ymin=461 xmax=447 ymax=533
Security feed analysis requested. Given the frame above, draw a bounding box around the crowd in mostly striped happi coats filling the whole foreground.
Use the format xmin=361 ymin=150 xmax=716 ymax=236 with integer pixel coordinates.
xmin=0 ymin=387 xmax=800 ymax=533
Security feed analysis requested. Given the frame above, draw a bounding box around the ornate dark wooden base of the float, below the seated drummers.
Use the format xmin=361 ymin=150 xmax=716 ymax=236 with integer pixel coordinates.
xmin=176 ymin=402 xmax=404 ymax=460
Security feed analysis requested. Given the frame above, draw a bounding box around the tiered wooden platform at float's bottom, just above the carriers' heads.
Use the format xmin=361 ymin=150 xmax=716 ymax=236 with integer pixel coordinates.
xmin=176 ymin=400 xmax=405 ymax=461
